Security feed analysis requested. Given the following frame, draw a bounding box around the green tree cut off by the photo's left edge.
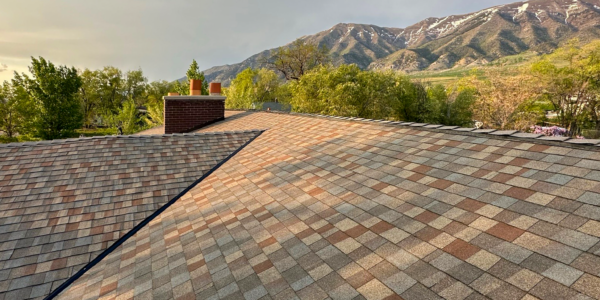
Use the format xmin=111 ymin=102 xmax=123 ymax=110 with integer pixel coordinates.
xmin=0 ymin=81 xmax=32 ymax=139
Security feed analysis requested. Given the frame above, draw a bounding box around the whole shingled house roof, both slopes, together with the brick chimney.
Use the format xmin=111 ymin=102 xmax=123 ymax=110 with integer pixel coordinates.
xmin=0 ymin=84 xmax=600 ymax=300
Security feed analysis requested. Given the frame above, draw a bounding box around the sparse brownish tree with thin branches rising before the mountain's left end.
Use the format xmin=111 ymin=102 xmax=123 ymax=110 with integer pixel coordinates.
xmin=261 ymin=39 xmax=329 ymax=80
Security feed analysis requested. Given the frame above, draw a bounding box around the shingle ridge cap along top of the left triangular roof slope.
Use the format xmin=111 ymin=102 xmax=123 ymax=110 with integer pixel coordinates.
xmin=0 ymin=129 xmax=266 ymax=148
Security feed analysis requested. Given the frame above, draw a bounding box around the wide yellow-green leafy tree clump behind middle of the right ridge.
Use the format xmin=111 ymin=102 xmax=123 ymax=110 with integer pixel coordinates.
xmin=286 ymin=65 xmax=473 ymax=126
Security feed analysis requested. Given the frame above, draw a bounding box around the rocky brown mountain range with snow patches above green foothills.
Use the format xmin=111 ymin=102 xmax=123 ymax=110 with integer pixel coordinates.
xmin=204 ymin=0 xmax=600 ymax=85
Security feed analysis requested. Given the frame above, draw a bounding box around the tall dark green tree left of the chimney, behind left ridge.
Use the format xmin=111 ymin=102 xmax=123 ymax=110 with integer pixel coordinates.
xmin=13 ymin=57 xmax=83 ymax=139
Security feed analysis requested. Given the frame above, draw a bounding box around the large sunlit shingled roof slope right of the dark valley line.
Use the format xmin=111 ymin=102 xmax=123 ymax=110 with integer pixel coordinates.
xmin=60 ymin=113 xmax=600 ymax=300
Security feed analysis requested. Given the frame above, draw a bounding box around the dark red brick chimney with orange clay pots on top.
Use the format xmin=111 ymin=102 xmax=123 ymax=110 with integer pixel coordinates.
xmin=163 ymin=79 xmax=225 ymax=134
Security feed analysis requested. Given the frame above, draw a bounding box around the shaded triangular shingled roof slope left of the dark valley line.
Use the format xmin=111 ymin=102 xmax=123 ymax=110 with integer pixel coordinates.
xmin=0 ymin=131 xmax=257 ymax=299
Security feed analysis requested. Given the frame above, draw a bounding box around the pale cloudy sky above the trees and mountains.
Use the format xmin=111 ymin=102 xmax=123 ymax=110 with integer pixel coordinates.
xmin=0 ymin=0 xmax=515 ymax=81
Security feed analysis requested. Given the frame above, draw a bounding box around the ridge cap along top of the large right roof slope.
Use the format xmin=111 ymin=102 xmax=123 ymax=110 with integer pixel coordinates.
xmin=264 ymin=111 xmax=600 ymax=150
